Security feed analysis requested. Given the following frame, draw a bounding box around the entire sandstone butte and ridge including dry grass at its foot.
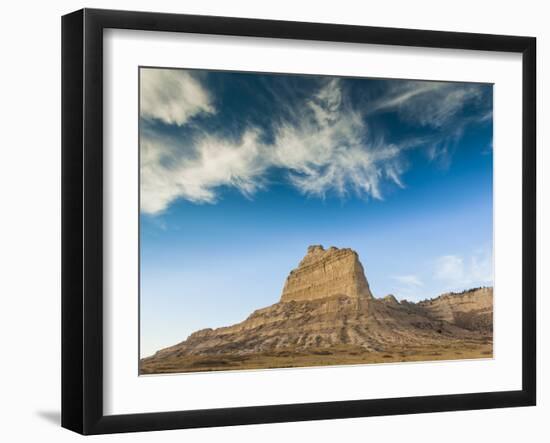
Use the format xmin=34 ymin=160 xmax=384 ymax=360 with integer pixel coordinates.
xmin=140 ymin=246 xmax=493 ymax=374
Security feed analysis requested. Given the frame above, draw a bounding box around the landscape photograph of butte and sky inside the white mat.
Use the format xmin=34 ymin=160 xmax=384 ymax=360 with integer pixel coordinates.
xmin=136 ymin=66 xmax=498 ymax=375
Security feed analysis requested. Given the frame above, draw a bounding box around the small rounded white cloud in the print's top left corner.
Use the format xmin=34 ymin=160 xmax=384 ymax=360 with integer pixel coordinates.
xmin=140 ymin=68 xmax=215 ymax=126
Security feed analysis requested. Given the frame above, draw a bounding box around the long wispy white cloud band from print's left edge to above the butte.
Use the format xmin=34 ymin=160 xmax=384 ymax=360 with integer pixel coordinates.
xmin=141 ymin=80 xmax=412 ymax=214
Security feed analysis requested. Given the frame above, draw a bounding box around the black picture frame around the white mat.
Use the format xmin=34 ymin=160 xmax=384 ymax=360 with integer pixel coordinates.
xmin=62 ymin=9 xmax=536 ymax=434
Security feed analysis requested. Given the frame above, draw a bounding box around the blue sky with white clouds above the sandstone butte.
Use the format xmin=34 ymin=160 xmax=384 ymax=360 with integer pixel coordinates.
xmin=140 ymin=68 xmax=493 ymax=356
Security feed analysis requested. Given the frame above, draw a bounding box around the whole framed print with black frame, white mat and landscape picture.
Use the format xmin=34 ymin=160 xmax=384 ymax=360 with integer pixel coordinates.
xmin=62 ymin=9 xmax=536 ymax=434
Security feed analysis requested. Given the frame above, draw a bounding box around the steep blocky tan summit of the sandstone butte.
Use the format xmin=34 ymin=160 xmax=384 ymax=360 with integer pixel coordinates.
xmin=281 ymin=246 xmax=372 ymax=302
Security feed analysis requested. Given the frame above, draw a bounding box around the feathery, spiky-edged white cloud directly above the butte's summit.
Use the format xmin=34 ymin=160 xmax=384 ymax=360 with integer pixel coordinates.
xmin=273 ymin=80 xmax=402 ymax=199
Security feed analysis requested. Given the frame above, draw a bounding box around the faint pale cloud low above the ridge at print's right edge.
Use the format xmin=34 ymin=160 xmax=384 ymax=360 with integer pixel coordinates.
xmin=434 ymin=250 xmax=493 ymax=290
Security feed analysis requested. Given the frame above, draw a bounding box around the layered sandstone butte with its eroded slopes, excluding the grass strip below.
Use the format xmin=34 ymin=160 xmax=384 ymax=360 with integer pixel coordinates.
xmin=146 ymin=246 xmax=493 ymax=363
